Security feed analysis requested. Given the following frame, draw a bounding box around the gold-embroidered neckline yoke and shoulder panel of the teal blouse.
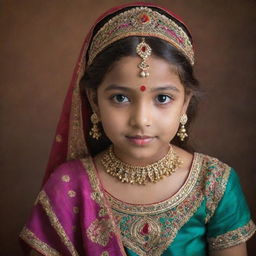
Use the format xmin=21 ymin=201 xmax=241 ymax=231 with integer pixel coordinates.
xmin=107 ymin=153 xmax=233 ymax=256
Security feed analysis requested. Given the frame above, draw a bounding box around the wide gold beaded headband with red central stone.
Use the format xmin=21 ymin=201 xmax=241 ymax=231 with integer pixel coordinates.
xmin=88 ymin=7 xmax=194 ymax=65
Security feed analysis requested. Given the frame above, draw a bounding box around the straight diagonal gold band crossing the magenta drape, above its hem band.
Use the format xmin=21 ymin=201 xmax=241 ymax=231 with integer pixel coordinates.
xmin=39 ymin=190 xmax=78 ymax=256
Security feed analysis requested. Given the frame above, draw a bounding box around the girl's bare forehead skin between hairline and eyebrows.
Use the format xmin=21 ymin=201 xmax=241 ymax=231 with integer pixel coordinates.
xmin=99 ymin=56 xmax=183 ymax=88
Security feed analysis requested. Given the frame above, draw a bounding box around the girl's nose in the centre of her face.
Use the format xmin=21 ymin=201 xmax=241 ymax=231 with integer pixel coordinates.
xmin=130 ymin=102 xmax=152 ymax=129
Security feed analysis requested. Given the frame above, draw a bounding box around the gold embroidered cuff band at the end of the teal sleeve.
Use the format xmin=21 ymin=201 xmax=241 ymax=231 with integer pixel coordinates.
xmin=208 ymin=220 xmax=256 ymax=250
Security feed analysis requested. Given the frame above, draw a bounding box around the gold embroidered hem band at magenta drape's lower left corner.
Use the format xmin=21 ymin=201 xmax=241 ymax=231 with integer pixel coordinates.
xmin=20 ymin=227 xmax=61 ymax=256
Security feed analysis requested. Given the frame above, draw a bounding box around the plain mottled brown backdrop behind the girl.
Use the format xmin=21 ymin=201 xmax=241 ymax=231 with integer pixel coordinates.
xmin=0 ymin=0 xmax=256 ymax=256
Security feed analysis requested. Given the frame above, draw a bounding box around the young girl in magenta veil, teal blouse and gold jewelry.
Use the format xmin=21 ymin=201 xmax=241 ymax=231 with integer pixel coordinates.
xmin=20 ymin=3 xmax=255 ymax=256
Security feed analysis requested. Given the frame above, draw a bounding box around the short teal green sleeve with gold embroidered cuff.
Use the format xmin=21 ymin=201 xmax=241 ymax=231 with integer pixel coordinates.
xmin=207 ymin=169 xmax=255 ymax=249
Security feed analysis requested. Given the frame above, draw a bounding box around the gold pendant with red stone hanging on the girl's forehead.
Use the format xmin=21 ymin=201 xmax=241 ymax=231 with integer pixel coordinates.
xmin=136 ymin=37 xmax=152 ymax=77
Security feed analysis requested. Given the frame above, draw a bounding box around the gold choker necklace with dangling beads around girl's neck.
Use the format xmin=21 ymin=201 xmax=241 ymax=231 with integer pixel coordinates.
xmin=101 ymin=145 xmax=182 ymax=185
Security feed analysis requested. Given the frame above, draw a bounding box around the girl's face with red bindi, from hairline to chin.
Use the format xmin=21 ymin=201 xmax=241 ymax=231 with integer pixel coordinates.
xmin=88 ymin=56 xmax=190 ymax=165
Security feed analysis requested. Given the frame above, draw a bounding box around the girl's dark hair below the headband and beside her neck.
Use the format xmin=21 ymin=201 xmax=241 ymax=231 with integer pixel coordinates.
xmin=80 ymin=7 xmax=199 ymax=155
